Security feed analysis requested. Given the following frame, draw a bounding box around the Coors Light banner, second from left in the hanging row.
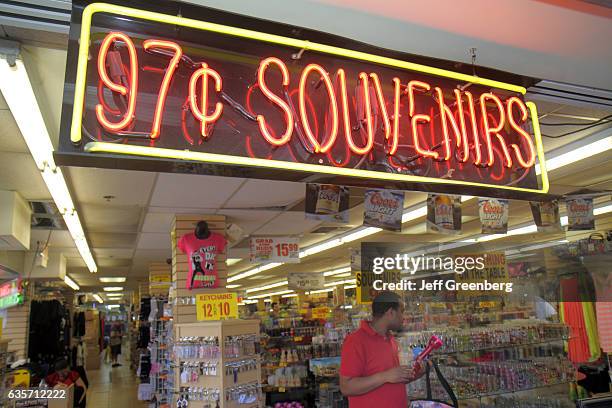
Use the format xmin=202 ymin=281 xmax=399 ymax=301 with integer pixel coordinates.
xmin=363 ymin=190 xmax=404 ymax=231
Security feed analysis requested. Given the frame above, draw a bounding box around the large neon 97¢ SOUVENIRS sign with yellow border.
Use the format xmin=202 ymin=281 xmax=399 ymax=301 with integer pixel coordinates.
xmin=56 ymin=1 xmax=548 ymax=197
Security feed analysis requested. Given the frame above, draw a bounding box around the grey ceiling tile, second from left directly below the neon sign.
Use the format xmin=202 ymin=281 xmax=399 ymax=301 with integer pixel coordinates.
xmin=150 ymin=174 xmax=244 ymax=208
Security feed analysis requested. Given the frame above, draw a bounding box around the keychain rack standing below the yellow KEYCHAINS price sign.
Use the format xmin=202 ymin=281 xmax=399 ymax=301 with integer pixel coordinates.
xmin=172 ymin=319 xmax=264 ymax=408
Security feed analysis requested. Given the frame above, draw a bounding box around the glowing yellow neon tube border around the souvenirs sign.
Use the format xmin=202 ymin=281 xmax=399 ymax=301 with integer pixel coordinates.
xmin=70 ymin=3 xmax=549 ymax=193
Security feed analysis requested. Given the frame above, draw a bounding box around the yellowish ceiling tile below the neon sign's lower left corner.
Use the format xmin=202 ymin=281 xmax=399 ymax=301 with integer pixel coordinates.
xmin=66 ymin=167 xmax=156 ymax=207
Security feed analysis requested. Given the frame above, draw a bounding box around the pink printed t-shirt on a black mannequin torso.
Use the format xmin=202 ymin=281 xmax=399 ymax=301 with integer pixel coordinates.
xmin=178 ymin=232 xmax=225 ymax=289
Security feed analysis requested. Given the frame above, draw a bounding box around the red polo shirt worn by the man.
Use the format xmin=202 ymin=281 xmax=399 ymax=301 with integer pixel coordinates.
xmin=340 ymin=320 xmax=408 ymax=408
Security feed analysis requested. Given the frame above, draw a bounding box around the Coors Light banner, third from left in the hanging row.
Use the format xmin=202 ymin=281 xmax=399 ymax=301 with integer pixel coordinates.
xmin=427 ymin=194 xmax=461 ymax=234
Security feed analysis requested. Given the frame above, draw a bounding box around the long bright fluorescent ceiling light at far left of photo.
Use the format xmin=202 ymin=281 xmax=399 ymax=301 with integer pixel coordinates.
xmin=0 ymin=58 xmax=98 ymax=272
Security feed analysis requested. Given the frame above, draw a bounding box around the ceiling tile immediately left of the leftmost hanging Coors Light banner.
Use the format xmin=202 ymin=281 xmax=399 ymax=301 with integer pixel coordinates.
xmin=224 ymin=180 xmax=306 ymax=208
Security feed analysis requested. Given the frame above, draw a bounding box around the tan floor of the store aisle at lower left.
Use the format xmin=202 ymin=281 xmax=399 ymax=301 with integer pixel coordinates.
xmin=87 ymin=357 xmax=146 ymax=408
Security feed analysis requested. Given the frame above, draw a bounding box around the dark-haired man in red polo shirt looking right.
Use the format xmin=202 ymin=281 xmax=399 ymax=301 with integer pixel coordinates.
xmin=340 ymin=292 xmax=424 ymax=408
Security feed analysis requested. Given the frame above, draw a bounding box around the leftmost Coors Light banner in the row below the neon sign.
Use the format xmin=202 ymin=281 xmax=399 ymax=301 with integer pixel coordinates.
xmin=306 ymin=184 xmax=349 ymax=224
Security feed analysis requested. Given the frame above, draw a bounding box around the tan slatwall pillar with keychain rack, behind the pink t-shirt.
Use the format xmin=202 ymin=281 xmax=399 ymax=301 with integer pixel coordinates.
xmin=170 ymin=215 xmax=263 ymax=408
